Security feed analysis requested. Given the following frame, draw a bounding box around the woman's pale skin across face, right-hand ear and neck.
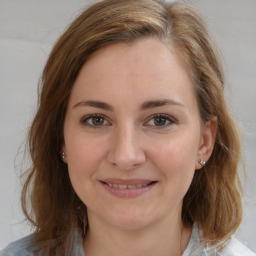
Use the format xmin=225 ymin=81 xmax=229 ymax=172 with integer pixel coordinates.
xmin=62 ymin=38 xmax=217 ymax=256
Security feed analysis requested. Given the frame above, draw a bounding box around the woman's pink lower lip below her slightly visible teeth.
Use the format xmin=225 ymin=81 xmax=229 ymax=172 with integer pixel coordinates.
xmin=100 ymin=182 xmax=157 ymax=198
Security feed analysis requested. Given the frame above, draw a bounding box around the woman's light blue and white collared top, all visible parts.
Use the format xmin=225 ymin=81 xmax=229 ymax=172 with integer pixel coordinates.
xmin=0 ymin=224 xmax=256 ymax=256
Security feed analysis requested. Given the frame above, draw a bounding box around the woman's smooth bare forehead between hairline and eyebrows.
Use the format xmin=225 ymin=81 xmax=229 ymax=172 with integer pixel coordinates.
xmin=68 ymin=38 xmax=198 ymax=109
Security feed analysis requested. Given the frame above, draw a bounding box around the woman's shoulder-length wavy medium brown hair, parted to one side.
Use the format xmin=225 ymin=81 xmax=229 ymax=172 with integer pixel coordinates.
xmin=22 ymin=0 xmax=242 ymax=255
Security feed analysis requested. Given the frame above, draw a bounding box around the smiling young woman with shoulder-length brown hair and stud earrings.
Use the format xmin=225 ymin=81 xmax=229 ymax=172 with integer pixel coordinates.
xmin=0 ymin=0 xmax=255 ymax=256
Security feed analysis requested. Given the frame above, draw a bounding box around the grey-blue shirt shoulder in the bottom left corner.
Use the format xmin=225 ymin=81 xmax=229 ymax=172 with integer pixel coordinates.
xmin=0 ymin=234 xmax=35 ymax=256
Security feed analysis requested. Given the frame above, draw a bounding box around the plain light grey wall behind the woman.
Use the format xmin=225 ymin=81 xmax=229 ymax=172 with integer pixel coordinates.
xmin=0 ymin=0 xmax=256 ymax=251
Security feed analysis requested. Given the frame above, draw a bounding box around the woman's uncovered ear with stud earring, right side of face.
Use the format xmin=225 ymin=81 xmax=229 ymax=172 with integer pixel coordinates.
xmin=195 ymin=116 xmax=218 ymax=170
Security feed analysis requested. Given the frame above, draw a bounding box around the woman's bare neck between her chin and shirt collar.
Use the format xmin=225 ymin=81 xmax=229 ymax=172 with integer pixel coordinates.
xmin=84 ymin=210 xmax=191 ymax=256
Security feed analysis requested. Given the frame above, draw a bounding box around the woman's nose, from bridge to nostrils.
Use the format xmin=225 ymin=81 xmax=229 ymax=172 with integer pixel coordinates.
xmin=107 ymin=126 xmax=146 ymax=171
